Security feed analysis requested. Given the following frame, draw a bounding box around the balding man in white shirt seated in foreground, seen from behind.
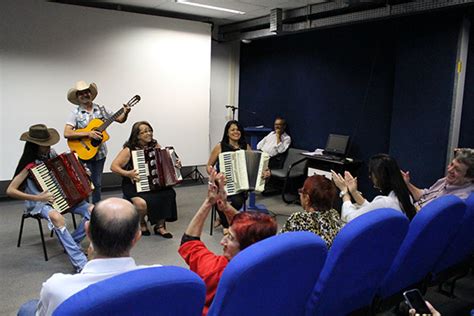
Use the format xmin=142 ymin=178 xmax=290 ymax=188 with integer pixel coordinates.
xmin=18 ymin=198 xmax=161 ymax=315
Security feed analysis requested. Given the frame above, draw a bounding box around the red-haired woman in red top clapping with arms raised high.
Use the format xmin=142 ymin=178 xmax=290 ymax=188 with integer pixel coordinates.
xmin=179 ymin=169 xmax=277 ymax=315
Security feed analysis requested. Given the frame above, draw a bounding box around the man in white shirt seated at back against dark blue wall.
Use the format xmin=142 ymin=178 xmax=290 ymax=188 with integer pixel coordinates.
xmin=257 ymin=117 xmax=291 ymax=169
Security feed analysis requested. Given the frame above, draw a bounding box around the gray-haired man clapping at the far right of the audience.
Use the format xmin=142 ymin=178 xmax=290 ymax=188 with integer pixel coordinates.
xmin=402 ymin=148 xmax=474 ymax=208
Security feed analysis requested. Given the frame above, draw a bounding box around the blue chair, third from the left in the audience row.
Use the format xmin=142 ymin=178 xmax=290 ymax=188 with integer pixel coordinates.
xmin=306 ymin=208 xmax=409 ymax=315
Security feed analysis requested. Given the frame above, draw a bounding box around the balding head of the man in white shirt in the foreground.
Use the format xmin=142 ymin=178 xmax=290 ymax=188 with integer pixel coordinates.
xmin=88 ymin=198 xmax=140 ymax=257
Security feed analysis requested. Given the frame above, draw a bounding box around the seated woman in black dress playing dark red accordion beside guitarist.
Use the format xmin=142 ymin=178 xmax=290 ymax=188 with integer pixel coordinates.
xmin=110 ymin=121 xmax=178 ymax=238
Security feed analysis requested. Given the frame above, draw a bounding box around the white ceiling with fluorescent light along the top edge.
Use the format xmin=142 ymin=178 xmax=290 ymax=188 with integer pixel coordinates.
xmin=89 ymin=0 xmax=327 ymax=25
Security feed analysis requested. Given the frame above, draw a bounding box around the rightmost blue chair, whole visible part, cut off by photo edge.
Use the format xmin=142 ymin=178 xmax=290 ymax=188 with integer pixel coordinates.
xmin=430 ymin=193 xmax=474 ymax=296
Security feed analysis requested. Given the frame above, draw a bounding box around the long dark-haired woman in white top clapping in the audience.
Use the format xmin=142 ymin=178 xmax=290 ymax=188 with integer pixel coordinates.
xmin=332 ymin=154 xmax=416 ymax=223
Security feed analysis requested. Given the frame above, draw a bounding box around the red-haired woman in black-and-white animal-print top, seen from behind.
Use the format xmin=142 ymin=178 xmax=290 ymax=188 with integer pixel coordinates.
xmin=280 ymin=175 xmax=343 ymax=247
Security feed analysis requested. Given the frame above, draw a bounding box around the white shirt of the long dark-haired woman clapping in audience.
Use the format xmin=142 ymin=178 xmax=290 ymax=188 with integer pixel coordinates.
xmin=341 ymin=191 xmax=403 ymax=223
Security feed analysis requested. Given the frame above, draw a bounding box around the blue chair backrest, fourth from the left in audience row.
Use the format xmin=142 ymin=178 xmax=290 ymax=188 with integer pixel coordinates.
xmin=378 ymin=195 xmax=466 ymax=298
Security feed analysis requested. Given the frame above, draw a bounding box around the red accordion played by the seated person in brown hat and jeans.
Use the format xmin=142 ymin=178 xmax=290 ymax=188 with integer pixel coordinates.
xmin=30 ymin=153 xmax=92 ymax=213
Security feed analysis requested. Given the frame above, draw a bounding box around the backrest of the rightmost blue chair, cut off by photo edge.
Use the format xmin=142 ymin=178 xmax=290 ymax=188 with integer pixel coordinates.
xmin=433 ymin=193 xmax=474 ymax=274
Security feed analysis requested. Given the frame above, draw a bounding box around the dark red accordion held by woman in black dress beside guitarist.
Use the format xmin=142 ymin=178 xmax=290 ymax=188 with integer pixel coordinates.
xmin=132 ymin=147 xmax=183 ymax=192
